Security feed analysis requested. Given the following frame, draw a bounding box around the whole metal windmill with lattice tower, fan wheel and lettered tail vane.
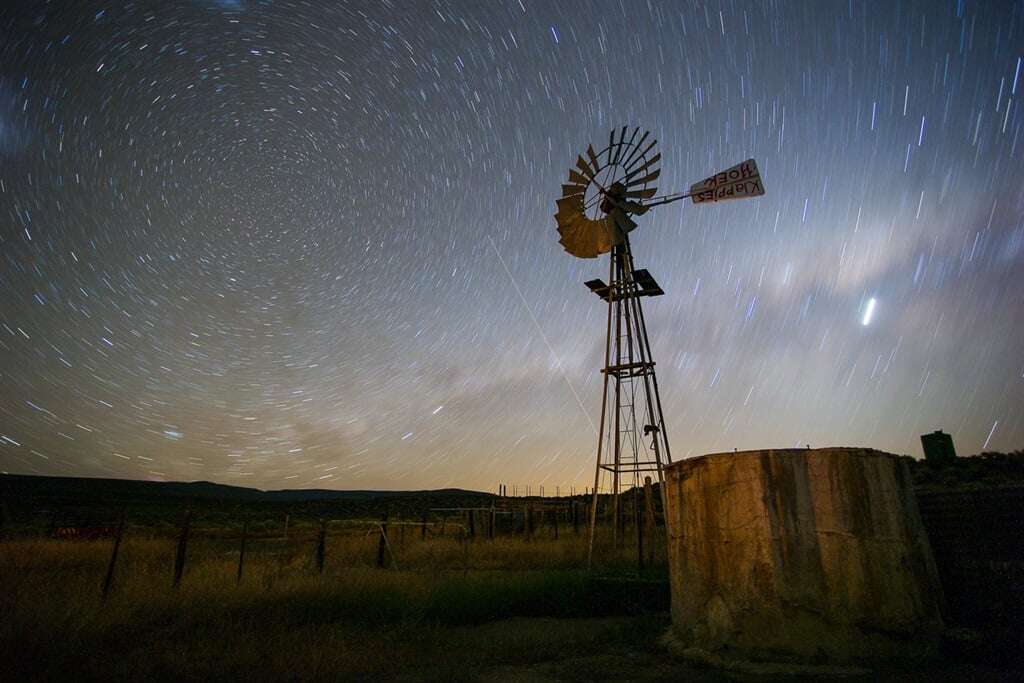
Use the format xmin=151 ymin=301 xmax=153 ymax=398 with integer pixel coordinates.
xmin=555 ymin=126 xmax=764 ymax=563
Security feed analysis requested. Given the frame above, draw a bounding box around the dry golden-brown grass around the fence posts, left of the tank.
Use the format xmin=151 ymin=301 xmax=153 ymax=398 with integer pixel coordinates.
xmin=0 ymin=529 xmax=664 ymax=680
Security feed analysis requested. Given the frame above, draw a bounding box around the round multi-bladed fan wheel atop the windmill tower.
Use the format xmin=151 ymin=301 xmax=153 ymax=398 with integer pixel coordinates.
xmin=555 ymin=126 xmax=662 ymax=258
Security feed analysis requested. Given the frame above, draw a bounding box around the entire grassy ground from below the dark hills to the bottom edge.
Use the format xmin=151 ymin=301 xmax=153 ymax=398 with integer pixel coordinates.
xmin=0 ymin=479 xmax=1019 ymax=681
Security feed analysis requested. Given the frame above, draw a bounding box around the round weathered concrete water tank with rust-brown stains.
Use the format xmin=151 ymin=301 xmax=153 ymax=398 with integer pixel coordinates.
xmin=666 ymin=449 xmax=942 ymax=661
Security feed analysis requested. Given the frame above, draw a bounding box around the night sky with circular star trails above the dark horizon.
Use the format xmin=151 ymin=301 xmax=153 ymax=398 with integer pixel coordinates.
xmin=0 ymin=0 xmax=1024 ymax=493
